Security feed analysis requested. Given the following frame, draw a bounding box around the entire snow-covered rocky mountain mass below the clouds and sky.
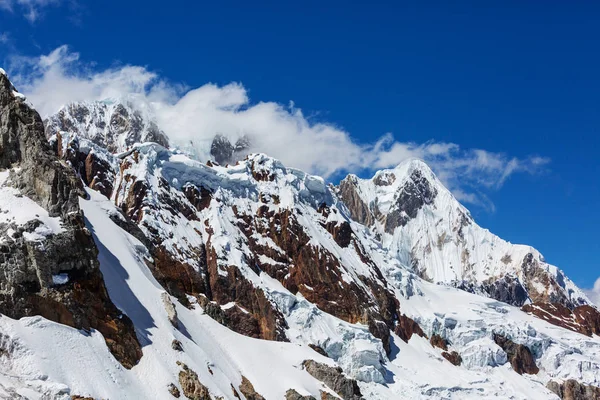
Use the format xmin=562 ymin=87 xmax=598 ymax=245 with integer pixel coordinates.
xmin=0 ymin=69 xmax=600 ymax=400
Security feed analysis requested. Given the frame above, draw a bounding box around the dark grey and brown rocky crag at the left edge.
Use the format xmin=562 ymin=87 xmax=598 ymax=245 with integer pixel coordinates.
xmin=0 ymin=74 xmax=142 ymax=368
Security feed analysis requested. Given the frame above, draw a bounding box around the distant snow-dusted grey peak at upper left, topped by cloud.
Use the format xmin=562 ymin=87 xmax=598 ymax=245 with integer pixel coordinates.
xmin=45 ymin=101 xmax=169 ymax=153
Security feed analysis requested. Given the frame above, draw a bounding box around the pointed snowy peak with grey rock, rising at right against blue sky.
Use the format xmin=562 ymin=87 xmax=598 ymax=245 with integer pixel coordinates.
xmin=339 ymin=160 xmax=590 ymax=308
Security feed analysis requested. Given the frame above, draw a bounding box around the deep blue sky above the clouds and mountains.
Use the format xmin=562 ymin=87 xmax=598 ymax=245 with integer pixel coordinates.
xmin=0 ymin=0 xmax=600 ymax=288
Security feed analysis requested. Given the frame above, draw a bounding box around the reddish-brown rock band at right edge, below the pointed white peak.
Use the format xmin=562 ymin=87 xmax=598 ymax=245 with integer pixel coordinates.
xmin=521 ymin=303 xmax=600 ymax=336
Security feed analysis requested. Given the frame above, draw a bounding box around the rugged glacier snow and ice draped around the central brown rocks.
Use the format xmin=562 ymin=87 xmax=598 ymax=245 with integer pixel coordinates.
xmin=69 ymin=140 xmax=600 ymax=399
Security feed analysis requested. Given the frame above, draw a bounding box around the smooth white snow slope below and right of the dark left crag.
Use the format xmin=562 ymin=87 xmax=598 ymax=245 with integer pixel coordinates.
xmin=0 ymin=190 xmax=342 ymax=399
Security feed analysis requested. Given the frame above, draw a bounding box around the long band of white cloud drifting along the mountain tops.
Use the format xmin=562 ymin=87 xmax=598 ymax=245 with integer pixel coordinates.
xmin=5 ymin=46 xmax=549 ymax=210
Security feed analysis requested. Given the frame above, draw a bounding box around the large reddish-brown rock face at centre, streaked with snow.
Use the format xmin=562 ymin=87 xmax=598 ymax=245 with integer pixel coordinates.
xmin=237 ymin=205 xmax=398 ymax=352
